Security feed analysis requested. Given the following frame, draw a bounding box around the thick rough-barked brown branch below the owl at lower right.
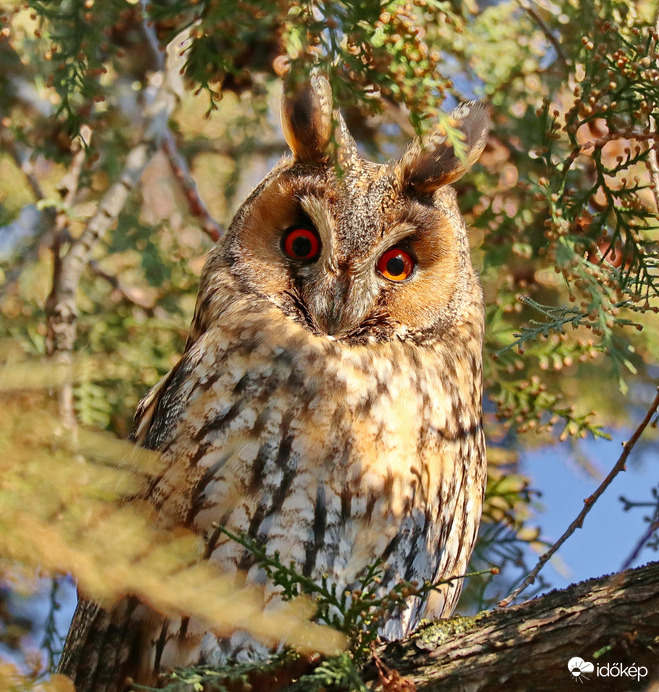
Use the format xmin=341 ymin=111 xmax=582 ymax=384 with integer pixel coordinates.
xmin=372 ymin=562 xmax=659 ymax=692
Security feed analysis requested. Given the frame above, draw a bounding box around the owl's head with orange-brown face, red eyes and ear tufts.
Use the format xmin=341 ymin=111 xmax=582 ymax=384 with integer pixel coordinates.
xmin=200 ymin=77 xmax=488 ymax=343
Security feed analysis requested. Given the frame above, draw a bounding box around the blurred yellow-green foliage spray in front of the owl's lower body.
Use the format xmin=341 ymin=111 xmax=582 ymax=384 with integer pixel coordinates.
xmin=0 ymin=366 xmax=345 ymax=660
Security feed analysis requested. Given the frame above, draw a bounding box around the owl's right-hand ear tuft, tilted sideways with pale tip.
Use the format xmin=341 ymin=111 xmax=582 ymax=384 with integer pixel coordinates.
xmin=400 ymin=101 xmax=490 ymax=194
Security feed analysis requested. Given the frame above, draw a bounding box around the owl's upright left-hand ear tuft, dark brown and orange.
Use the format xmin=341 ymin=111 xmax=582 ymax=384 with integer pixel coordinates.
xmin=281 ymin=75 xmax=333 ymax=163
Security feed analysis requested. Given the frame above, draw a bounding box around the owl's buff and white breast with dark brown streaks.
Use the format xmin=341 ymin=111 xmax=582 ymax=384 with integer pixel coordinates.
xmin=144 ymin=288 xmax=484 ymax=644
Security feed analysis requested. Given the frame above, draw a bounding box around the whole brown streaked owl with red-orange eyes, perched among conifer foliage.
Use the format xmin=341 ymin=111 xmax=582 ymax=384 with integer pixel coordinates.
xmin=61 ymin=81 xmax=486 ymax=692
